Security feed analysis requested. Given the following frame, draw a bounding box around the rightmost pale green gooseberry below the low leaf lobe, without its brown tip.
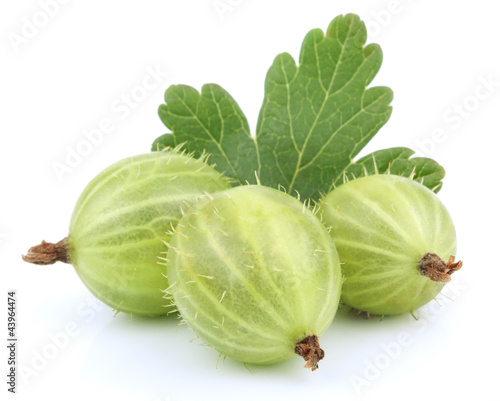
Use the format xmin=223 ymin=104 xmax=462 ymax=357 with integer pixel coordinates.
xmin=320 ymin=175 xmax=456 ymax=315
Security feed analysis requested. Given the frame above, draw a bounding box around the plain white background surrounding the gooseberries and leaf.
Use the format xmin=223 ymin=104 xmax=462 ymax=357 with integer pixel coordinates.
xmin=0 ymin=0 xmax=500 ymax=401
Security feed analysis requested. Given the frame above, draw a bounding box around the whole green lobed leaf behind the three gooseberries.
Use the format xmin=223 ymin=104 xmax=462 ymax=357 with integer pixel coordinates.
xmin=152 ymin=14 xmax=444 ymax=200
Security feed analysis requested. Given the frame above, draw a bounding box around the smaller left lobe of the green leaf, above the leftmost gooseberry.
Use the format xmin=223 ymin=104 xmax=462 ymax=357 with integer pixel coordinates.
xmin=157 ymin=84 xmax=258 ymax=184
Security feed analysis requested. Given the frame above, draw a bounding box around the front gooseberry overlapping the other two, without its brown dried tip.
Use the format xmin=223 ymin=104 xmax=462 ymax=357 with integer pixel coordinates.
xmin=167 ymin=185 xmax=341 ymax=370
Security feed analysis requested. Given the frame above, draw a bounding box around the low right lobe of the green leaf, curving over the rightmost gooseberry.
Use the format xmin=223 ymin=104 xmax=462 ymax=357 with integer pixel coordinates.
xmin=336 ymin=148 xmax=445 ymax=193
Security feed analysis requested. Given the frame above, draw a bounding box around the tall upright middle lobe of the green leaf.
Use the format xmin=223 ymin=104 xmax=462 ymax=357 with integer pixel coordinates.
xmin=257 ymin=14 xmax=392 ymax=198
